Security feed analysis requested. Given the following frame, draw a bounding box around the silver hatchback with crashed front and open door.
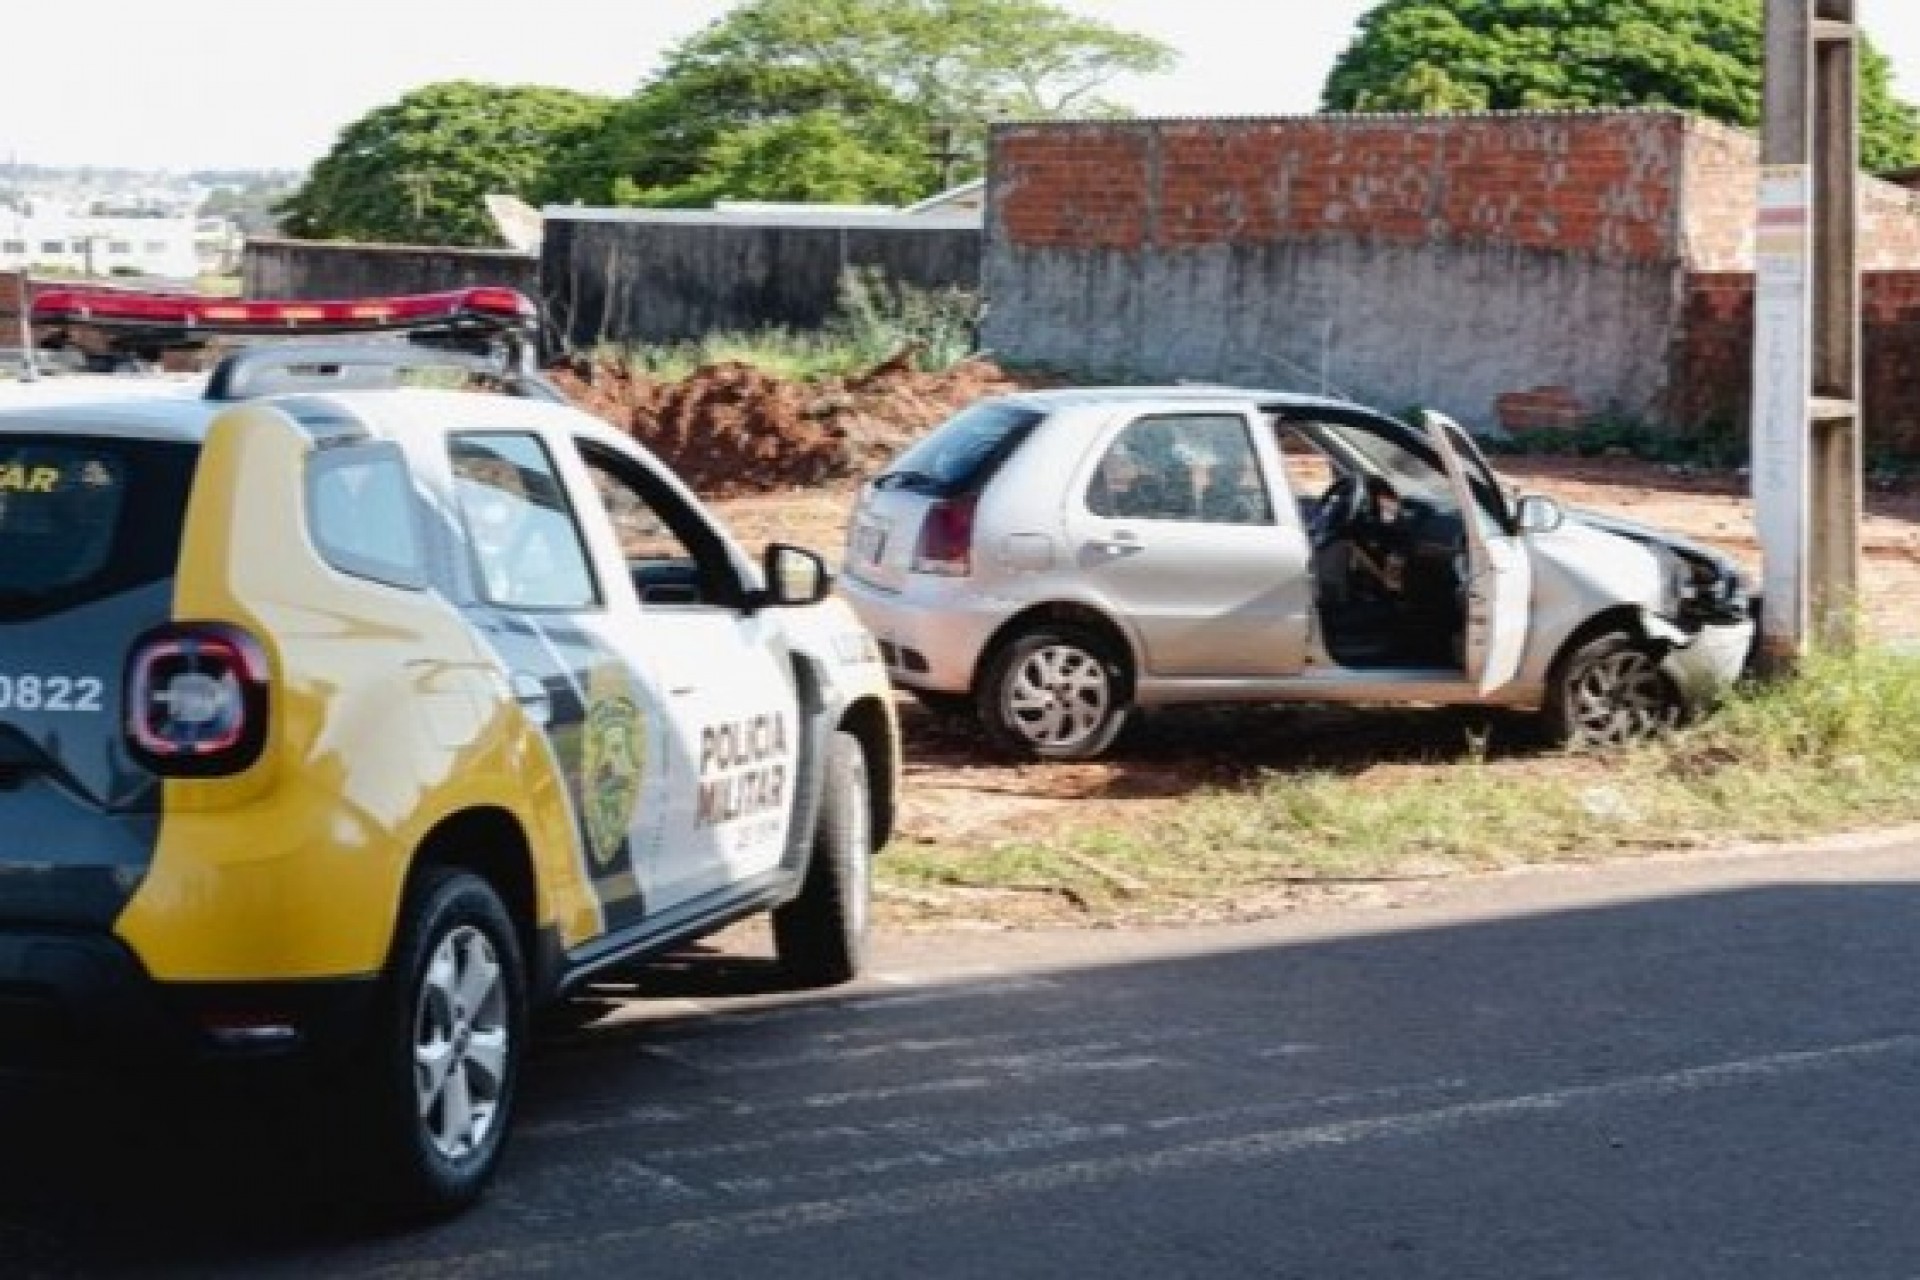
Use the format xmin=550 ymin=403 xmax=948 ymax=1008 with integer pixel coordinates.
xmin=841 ymin=386 xmax=1753 ymax=760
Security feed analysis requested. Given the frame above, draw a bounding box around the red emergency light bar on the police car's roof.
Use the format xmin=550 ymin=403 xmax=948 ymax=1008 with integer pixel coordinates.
xmin=33 ymin=286 xmax=540 ymax=336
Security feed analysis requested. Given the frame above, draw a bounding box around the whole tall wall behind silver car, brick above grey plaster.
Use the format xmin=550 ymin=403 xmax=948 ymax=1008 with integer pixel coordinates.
xmin=985 ymin=111 xmax=1688 ymax=424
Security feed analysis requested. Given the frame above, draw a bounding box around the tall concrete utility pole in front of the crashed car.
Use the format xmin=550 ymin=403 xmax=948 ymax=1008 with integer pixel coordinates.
xmin=1753 ymin=0 xmax=1862 ymax=668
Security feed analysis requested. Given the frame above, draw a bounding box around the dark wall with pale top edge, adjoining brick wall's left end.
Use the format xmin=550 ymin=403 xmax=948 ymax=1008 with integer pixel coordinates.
xmin=541 ymin=207 xmax=981 ymax=347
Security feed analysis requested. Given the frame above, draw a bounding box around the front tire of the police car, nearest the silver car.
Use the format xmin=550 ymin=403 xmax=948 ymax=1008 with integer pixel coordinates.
xmin=774 ymin=731 xmax=874 ymax=986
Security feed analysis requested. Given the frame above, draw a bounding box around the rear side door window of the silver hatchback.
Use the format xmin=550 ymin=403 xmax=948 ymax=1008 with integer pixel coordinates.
xmin=1085 ymin=415 xmax=1273 ymax=524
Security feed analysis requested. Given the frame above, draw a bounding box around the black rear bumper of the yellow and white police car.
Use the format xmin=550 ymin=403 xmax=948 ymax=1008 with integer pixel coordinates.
xmin=0 ymin=927 xmax=374 ymax=1071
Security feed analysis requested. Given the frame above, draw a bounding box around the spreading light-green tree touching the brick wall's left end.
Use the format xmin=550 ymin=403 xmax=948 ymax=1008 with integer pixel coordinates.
xmin=582 ymin=0 xmax=1173 ymax=205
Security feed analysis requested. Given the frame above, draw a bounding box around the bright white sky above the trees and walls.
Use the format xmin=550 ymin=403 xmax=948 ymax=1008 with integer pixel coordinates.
xmin=11 ymin=0 xmax=1920 ymax=171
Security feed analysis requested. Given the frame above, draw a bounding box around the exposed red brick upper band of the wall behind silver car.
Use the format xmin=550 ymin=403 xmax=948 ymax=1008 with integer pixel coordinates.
xmin=991 ymin=111 xmax=1688 ymax=261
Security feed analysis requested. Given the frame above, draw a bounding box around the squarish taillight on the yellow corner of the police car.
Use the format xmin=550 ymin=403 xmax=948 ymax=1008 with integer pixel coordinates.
xmin=127 ymin=626 xmax=269 ymax=777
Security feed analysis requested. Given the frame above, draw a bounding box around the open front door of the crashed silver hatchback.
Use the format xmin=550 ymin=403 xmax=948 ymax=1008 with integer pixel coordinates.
xmin=1421 ymin=409 xmax=1534 ymax=695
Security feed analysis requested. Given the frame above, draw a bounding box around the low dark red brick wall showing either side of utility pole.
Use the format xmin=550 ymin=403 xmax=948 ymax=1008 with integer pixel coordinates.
xmin=1674 ymin=271 xmax=1920 ymax=457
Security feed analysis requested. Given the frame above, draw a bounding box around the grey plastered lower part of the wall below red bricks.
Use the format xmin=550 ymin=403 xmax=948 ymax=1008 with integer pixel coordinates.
xmin=983 ymin=242 xmax=1674 ymax=424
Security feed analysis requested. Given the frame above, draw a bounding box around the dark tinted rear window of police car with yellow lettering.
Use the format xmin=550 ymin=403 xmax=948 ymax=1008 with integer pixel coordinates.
xmin=0 ymin=434 xmax=196 ymax=620
